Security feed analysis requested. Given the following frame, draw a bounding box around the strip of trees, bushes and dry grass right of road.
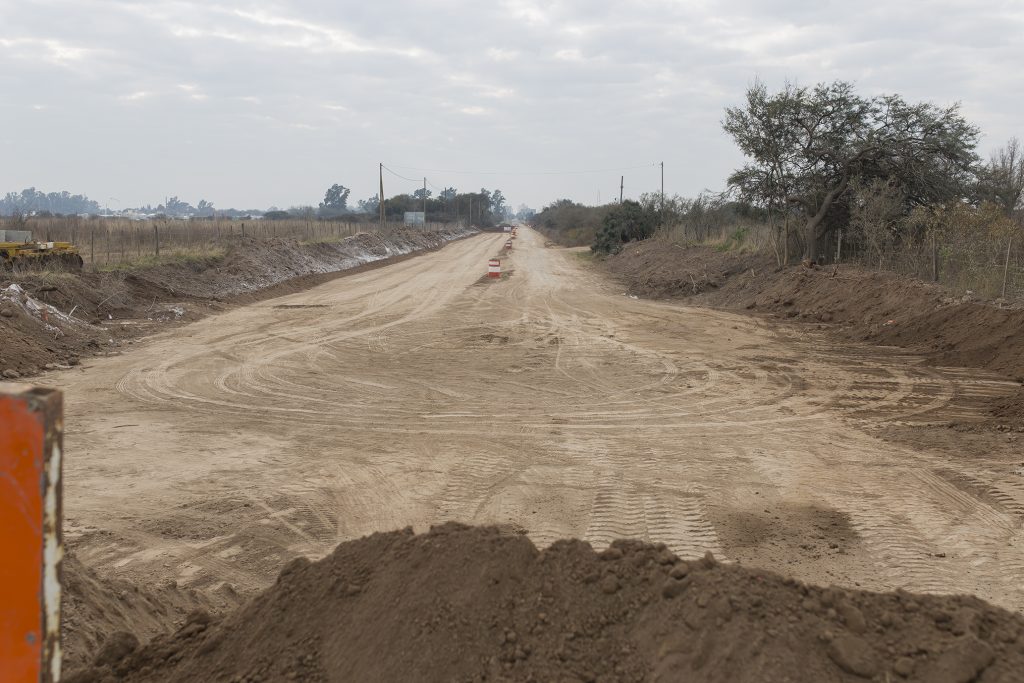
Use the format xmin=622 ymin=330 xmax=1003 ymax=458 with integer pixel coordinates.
xmin=532 ymin=82 xmax=1024 ymax=300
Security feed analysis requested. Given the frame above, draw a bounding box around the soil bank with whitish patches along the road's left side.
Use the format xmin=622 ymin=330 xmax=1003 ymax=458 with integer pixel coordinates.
xmin=0 ymin=229 xmax=475 ymax=381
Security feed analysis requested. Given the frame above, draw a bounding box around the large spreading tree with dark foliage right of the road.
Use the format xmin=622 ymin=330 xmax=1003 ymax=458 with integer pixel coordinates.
xmin=723 ymin=81 xmax=978 ymax=260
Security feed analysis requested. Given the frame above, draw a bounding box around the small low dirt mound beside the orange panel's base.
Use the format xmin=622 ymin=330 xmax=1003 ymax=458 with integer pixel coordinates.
xmin=61 ymin=555 xmax=222 ymax=669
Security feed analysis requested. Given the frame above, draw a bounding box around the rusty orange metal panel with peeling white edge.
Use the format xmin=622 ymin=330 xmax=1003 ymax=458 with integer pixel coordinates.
xmin=0 ymin=384 xmax=63 ymax=683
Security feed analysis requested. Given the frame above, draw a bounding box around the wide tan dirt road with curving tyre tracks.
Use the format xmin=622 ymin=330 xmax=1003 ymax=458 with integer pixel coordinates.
xmin=47 ymin=230 xmax=1024 ymax=610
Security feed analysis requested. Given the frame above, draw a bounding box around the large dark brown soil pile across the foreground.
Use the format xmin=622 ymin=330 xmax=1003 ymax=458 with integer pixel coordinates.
xmin=66 ymin=523 xmax=1024 ymax=683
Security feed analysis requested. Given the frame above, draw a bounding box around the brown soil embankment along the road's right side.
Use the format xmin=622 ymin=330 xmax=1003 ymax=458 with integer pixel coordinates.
xmin=604 ymin=240 xmax=1024 ymax=427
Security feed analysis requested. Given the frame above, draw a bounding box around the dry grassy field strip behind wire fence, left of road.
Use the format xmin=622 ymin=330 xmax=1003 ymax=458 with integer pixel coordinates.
xmin=12 ymin=218 xmax=445 ymax=268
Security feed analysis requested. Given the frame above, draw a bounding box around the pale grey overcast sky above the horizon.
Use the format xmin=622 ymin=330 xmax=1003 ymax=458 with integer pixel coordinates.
xmin=0 ymin=0 xmax=1024 ymax=208
